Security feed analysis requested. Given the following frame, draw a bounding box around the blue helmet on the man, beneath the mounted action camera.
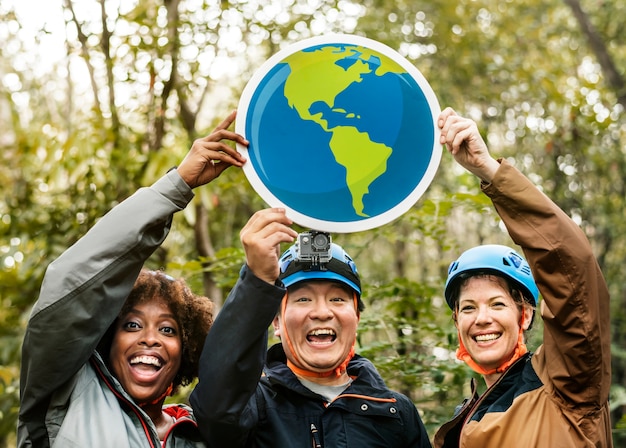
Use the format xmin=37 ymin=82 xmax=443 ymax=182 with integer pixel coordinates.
xmin=279 ymin=234 xmax=365 ymax=311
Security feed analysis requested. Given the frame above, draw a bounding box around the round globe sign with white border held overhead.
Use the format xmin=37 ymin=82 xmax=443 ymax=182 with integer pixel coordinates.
xmin=236 ymin=34 xmax=442 ymax=233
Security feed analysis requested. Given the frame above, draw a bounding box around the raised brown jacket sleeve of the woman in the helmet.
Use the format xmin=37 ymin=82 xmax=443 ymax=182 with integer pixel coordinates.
xmin=483 ymin=160 xmax=611 ymax=409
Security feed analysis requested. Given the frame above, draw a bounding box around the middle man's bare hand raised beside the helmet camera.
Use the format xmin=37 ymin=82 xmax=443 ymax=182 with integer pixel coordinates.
xmin=239 ymin=208 xmax=298 ymax=284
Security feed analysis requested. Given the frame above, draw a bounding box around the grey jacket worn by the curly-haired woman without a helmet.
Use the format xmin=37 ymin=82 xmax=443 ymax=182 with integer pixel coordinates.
xmin=17 ymin=171 xmax=205 ymax=448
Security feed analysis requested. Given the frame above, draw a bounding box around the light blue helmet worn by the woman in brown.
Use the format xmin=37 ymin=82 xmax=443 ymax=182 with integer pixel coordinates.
xmin=444 ymin=244 xmax=539 ymax=310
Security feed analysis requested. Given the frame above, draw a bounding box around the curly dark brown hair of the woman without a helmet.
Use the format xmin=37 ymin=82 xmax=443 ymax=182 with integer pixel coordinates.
xmin=101 ymin=268 xmax=213 ymax=390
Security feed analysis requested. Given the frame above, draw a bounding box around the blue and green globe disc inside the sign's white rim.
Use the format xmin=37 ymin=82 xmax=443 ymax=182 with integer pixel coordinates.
xmin=245 ymin=43 xmax=435 ymax=222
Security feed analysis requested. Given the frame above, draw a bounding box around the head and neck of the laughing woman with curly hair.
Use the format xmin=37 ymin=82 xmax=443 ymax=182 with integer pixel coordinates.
xmin=98 ymin=269 xmax=213 ymax=440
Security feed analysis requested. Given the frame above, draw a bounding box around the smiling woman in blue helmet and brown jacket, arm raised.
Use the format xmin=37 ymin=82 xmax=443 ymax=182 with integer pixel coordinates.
xmin=434 ymin=108 xmax=612 ymax=448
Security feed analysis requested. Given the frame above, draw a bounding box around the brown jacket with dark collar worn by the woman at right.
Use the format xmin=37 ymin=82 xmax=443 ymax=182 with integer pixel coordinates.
xmin=434 ymin=160 xmax=613 ymax=448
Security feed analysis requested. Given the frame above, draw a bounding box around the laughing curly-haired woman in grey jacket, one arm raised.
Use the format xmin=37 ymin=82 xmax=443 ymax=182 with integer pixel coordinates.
xmin=18 ymin=112 xmax=246 ymax=448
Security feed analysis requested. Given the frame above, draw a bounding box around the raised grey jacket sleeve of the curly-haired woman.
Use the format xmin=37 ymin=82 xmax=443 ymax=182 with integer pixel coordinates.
xmin=20 ymin=170 xmax=193 ymax=415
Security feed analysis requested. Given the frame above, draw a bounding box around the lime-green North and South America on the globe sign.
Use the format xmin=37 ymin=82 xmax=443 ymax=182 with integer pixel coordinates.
xmin=283 ymin=46 xmax=402 ymax=217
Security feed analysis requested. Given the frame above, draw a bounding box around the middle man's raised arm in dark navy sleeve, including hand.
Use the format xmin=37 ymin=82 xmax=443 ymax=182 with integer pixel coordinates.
xmin=190 ymin=209 xmax=297 ymax=447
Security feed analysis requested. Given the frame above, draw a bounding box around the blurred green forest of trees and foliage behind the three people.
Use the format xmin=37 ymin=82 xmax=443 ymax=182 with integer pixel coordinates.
xmin=0 ymin=0 xmax=626 ymax=447
